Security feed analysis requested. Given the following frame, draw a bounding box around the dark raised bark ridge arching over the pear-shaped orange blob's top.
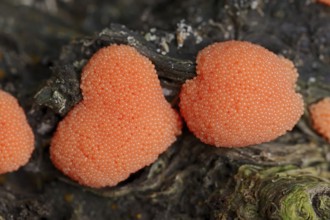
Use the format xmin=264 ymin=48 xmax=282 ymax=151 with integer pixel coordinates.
xmin=35 ymin=24 xmax=195 ymax=116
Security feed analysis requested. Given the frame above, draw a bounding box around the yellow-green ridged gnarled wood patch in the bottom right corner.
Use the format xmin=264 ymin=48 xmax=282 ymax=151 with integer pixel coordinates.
xmin=218 ymin=165 xmax=330 ymax=220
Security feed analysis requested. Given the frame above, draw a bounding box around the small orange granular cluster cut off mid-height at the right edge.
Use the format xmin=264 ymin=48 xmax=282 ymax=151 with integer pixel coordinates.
xmin=309 ymin=97 xmax=330 ymax=141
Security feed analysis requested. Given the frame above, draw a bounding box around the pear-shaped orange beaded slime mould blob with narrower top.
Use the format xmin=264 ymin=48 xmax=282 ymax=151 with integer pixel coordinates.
xmin=50 ymin=45 xmax=181 ymax=188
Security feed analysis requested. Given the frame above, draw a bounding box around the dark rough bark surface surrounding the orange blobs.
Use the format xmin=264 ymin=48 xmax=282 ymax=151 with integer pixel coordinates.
xmin=0 ymin=0 xmax=330 ymax=219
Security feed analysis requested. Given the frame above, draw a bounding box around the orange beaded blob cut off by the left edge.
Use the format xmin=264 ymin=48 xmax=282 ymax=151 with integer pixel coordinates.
xmin=0 ymin=90 xmax=34 ymax=174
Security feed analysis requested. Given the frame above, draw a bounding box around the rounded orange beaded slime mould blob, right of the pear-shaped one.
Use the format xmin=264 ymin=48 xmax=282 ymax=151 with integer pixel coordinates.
xmin=180 ymin=41 xmax=303 ymax=147
